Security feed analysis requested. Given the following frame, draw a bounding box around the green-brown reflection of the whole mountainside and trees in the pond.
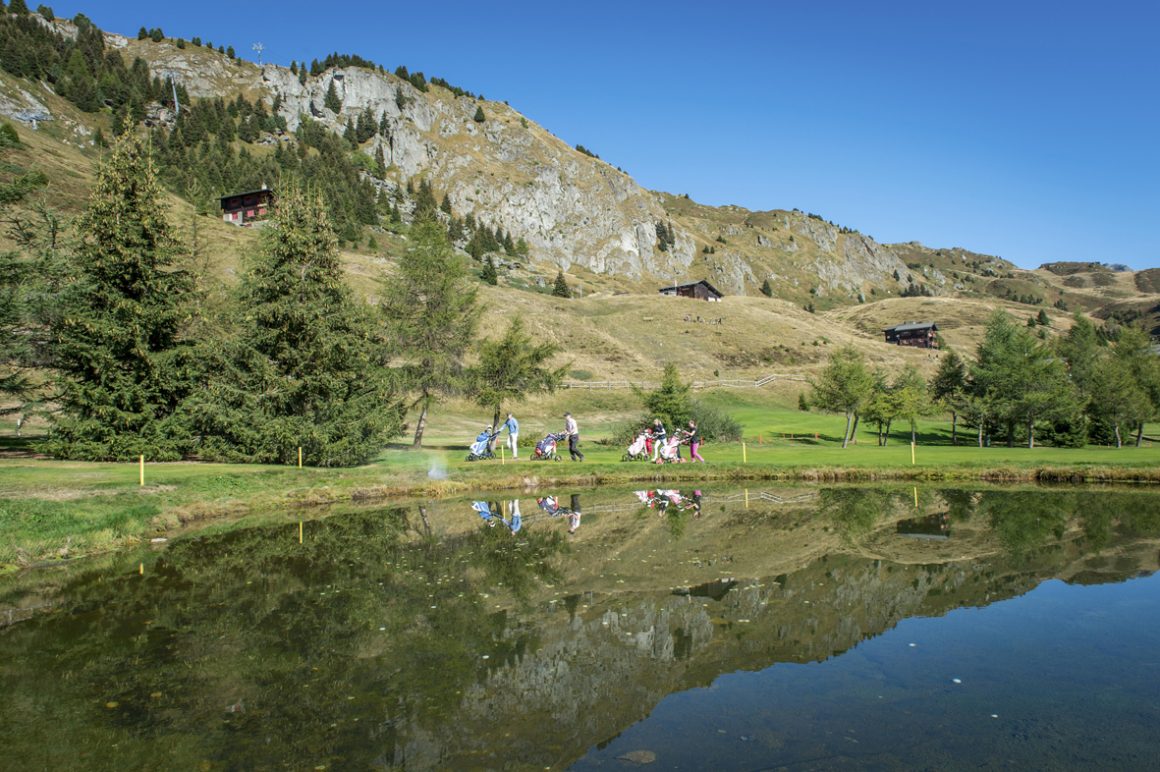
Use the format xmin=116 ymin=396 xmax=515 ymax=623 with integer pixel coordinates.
xmin=0 ymin=488 xmax=1160 ymax=767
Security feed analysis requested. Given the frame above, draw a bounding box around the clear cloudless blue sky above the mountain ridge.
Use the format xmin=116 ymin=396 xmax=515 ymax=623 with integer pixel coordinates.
xmin=47 ymin=0 xmax=1160 ymax=269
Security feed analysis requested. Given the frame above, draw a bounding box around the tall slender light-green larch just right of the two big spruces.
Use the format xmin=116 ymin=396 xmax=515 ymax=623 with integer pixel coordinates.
xmin=382 ymin=219 xmax=477 ymax=449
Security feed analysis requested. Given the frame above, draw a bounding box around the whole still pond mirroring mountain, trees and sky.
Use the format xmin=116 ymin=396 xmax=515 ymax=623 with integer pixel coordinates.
xmin=0 ymin=487 xmax=1160 ymax=770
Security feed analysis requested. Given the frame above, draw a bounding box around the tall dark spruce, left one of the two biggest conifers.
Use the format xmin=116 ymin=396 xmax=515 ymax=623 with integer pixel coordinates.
xmin=44 ymin=136 xmax=193 ymax=460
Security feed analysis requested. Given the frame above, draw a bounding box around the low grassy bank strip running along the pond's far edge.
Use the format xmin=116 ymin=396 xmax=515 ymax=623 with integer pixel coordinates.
xmin=0 ymin=435 xmax=1160 ymax=571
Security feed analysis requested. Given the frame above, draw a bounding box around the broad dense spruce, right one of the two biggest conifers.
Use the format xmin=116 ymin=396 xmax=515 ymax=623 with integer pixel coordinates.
xmin=187 ymin=188 xmax=403 ymax=466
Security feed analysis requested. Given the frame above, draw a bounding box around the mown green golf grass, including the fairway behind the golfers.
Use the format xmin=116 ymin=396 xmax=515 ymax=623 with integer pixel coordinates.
xmin=0 ymin=389 xmax=1160 ymax=567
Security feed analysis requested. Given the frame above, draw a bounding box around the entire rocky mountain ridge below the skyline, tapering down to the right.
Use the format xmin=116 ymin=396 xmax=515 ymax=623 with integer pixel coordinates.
xmin=0 ymin=20 xmax=1151 ymax=322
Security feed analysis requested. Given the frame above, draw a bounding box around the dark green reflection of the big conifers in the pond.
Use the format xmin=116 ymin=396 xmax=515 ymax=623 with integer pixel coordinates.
xmin=0 ymin=510 xmax=564 ymax=769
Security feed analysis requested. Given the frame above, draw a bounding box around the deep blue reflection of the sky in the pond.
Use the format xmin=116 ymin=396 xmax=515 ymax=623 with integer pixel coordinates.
xmin=575 ymin=567 xmax=1160 ymax=770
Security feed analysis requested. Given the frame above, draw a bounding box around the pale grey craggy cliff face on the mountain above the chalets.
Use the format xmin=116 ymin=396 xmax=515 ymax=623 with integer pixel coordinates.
xmin=0 ymin=21 xmax=941 ymax=295
